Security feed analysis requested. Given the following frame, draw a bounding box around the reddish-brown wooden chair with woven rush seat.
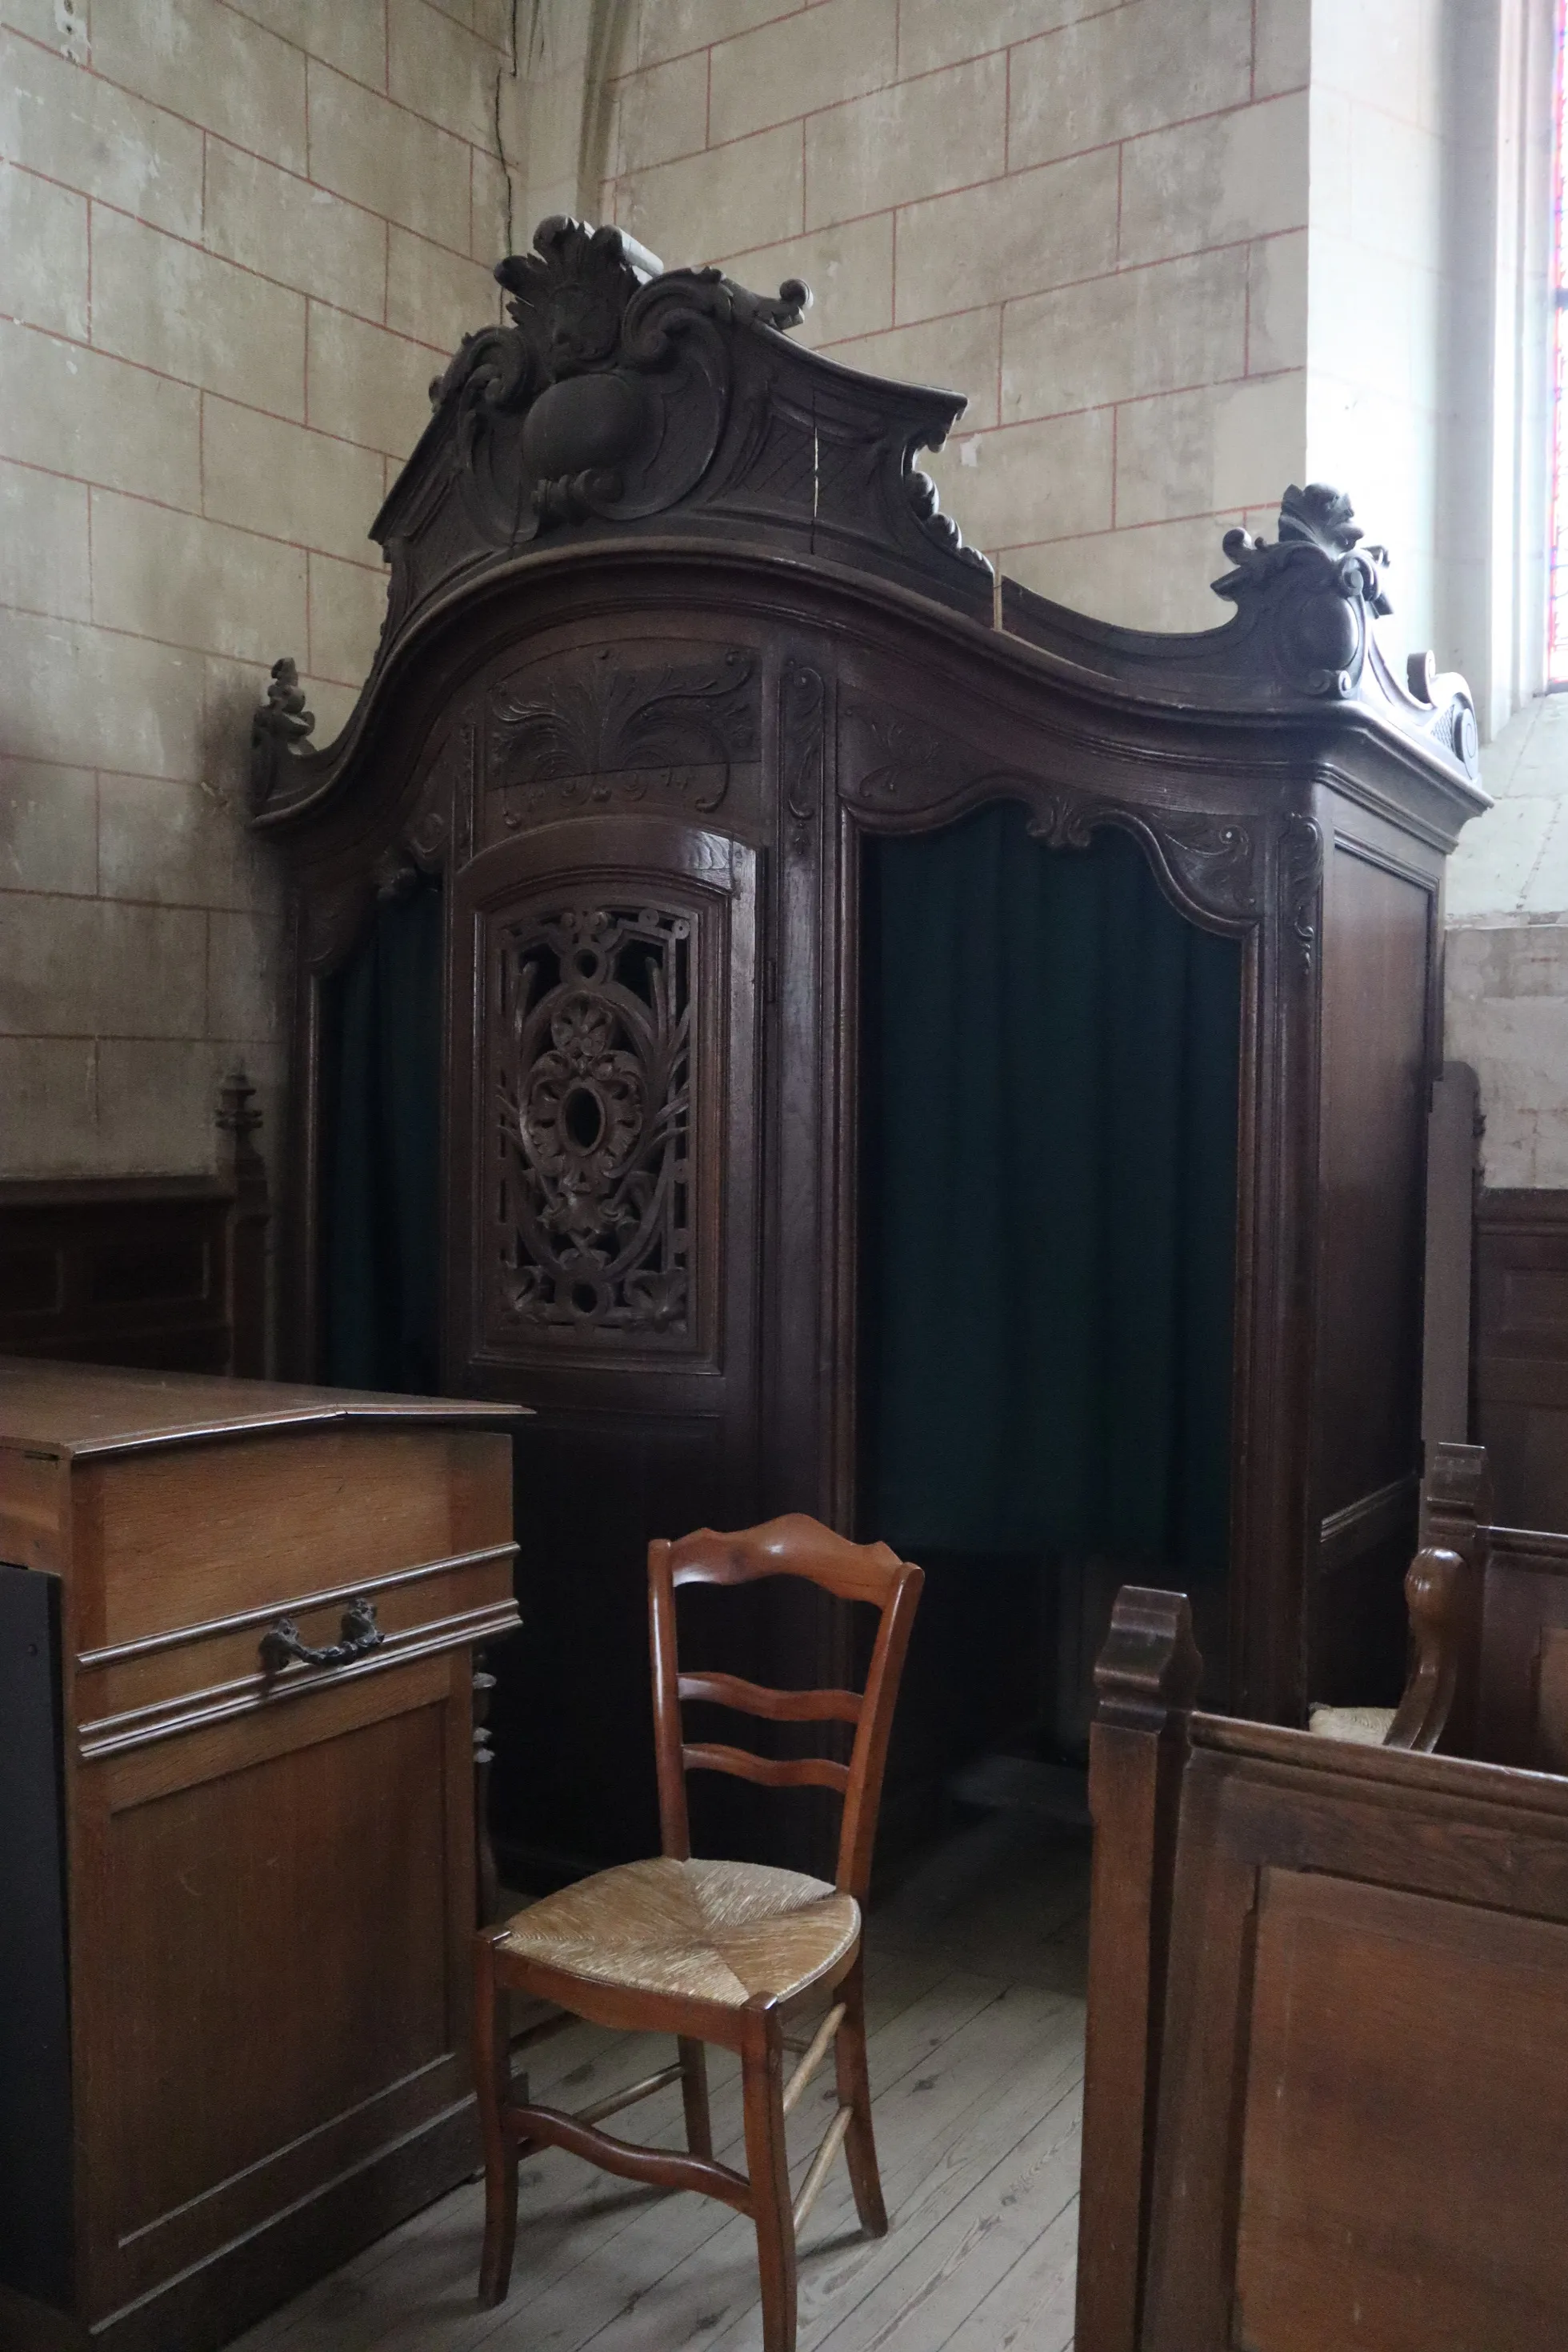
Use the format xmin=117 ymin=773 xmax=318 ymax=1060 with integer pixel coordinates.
xmin=475 ymin=1514 xmax=924 ymax=2352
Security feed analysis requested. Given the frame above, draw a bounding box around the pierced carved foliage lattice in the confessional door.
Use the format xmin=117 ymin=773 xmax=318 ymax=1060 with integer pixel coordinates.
xmin=486 ymin=884 xmax=719 ymax=1357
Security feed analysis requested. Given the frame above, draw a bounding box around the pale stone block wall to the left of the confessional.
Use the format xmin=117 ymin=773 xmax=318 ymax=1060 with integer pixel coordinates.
xmin=0 ymin=0 xmax=513 ymax=1174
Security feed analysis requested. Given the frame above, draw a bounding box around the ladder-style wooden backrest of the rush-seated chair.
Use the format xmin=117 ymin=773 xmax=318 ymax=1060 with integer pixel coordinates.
xmin=649 ymin=1512 xmax=924 ymax=1896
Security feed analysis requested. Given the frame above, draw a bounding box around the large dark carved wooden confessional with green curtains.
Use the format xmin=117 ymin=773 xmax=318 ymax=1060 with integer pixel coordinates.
xmin=254 ymin=221 xmax=1486 ymax=1872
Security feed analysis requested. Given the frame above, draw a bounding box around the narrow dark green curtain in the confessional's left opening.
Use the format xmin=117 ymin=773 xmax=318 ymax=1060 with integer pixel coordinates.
xmin=322 ymin=878 xmax=442 ymax=1394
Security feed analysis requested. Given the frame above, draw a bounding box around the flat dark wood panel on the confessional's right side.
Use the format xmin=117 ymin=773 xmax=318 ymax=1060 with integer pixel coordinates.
xmin=1307 ymin=814 xmax=1438 ymax=1701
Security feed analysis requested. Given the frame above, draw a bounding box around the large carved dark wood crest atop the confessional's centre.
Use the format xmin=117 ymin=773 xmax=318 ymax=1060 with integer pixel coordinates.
xmin=371 ymin=218 xmax=992 ymax=645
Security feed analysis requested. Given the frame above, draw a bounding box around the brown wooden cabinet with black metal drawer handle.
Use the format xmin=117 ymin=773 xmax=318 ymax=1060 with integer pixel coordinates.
xmin=0 ymin=1359 xmax=517 ymax=2352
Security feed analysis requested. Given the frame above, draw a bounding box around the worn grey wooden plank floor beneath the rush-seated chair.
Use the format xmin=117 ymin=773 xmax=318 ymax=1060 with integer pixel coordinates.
xmin=233 ymin=1816 xmax=1089 ymax=2352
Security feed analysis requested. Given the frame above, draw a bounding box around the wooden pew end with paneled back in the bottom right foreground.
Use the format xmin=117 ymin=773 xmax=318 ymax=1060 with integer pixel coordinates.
xmin=1077 ymin=1580 xmax=1568 ymax=2352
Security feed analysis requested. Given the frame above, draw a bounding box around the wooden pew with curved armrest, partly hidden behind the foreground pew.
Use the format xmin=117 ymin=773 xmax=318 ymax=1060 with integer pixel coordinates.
xmin=1312 ymin=1444 xmax=1568 ymax=1771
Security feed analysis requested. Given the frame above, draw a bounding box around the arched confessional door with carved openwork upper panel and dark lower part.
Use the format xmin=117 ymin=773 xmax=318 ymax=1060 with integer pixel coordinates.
xmin=444 ymin=814 xmax=762 ymax=1877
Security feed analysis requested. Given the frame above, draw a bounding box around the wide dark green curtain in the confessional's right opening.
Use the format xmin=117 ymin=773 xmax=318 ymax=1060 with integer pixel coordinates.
xmin=865 ymin=804 xmax=1242 ymax=1581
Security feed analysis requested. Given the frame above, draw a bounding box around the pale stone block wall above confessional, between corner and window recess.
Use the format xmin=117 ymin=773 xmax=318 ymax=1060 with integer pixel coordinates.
xmin=602 ymin=0 xmax=1310 ymax=628
